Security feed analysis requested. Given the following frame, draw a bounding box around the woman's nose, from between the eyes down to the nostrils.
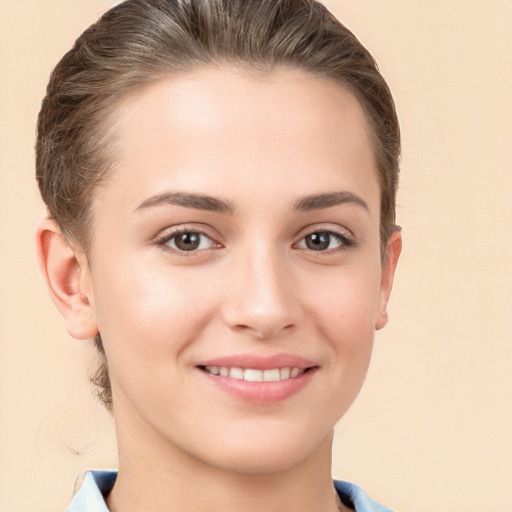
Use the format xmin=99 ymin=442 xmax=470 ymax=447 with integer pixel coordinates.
xmin=223 ymin=246 xmax=301 ymax=339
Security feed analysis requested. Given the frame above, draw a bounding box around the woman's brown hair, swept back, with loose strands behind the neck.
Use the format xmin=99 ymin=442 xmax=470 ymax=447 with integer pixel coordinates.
xmin=36 ymin=0 xmax=400 ymax=409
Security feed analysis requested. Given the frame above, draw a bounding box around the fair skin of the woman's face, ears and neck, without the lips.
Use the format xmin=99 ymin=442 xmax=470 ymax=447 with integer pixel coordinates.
xmin=38 ymin=68 xmax=401 ymax=512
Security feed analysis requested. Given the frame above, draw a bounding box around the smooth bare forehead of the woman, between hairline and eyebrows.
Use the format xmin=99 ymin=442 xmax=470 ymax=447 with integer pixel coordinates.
xmin=94 ymin=67 xmax=378 ymax=214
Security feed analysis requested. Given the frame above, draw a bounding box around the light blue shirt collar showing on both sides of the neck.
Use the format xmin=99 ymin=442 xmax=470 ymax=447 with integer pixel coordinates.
xmin=67 ymin=471 xmax=392 ymax=512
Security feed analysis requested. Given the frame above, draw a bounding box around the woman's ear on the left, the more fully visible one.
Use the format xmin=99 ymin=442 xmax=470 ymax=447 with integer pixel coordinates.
xmin=36 ymin=219 xmax=98 ymax=340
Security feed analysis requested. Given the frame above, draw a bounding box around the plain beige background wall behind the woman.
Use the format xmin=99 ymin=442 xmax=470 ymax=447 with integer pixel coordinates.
xmin=0 ymin=0 xmax=512 ymax=512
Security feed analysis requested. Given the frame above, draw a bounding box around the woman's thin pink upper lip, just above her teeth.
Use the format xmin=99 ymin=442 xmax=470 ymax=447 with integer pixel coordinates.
xmin=197 ymin=354 xmax=318 ymax=370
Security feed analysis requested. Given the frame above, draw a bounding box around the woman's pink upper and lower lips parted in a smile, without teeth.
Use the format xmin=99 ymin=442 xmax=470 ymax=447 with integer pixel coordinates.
xmin=196 ymin=354 xmax=318 ymax=405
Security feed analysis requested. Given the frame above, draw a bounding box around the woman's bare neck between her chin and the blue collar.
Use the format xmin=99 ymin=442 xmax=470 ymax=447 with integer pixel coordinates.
xmin=107 ymin=420 xmax=348 ymax=512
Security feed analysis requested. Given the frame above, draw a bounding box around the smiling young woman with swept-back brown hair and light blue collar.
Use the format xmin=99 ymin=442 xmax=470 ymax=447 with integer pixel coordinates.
xmin=37 ymin=0 xmax=401 ymax=512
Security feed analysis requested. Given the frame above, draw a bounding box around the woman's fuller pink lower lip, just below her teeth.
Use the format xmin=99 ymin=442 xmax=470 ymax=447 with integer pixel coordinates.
xmin=199 ymin=368 xmax=317 ymax=405
